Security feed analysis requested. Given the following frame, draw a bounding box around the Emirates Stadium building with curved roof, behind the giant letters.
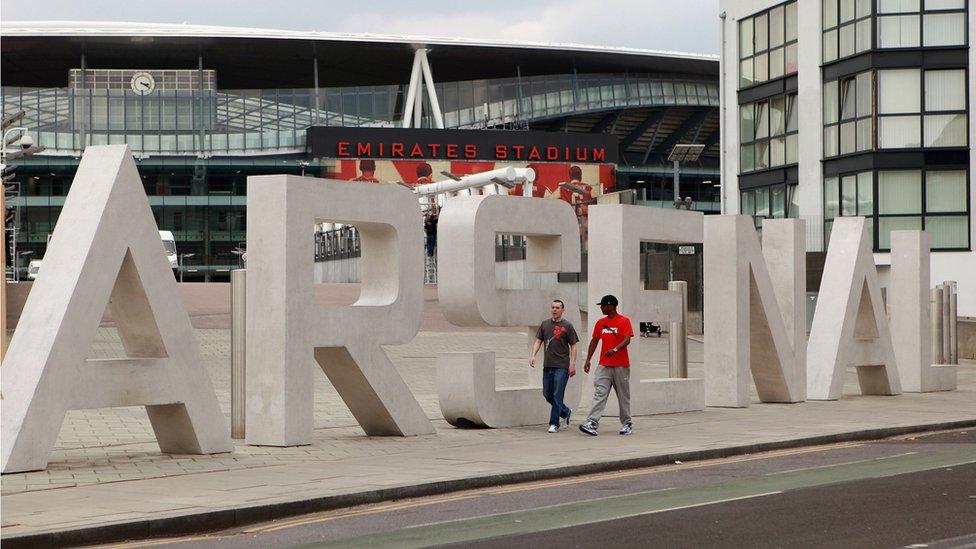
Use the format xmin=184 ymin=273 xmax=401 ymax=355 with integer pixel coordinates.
xmin=0 ymin=22 xmax=720 ymax=280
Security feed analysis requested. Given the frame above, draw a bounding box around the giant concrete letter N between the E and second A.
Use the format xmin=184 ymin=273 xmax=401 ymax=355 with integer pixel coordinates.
xmin=705 ymin=215 xmax=807 ymax=407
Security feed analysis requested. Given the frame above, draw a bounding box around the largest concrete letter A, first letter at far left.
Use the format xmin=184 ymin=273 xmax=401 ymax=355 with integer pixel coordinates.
xmin=2 ymin=145 xmax=232 ymax=473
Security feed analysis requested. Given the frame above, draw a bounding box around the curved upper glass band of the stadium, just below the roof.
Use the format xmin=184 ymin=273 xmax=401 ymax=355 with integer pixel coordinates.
xmin=0 ymin=74 xmax=718 ymax=155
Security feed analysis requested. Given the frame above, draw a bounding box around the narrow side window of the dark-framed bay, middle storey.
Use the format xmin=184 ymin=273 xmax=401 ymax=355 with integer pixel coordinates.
xmin=823 ymin=71 xmax=874 ymax=157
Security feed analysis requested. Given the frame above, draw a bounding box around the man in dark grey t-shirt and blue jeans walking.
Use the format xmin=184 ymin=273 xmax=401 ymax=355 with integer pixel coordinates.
xmin=529 ymin=299 xmax=579 ymax=433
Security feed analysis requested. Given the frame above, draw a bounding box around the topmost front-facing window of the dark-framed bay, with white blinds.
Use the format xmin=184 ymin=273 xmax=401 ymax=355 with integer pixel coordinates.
xmin=878 ymin=0 xmax=967 ymax=48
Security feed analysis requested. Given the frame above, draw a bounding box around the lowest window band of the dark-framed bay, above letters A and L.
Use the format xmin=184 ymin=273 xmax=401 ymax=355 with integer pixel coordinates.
xmin=824 ymin=170 xmax=970 ymax=251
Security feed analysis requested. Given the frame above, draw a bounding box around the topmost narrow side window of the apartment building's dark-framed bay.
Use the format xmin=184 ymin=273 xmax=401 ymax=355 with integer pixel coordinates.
xmin=822 ymin=0 xmax=872 ymax=63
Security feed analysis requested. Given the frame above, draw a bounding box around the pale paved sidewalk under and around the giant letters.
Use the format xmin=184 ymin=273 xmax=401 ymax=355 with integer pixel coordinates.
xmin=0 ymin=328 xmax=976 ymax=543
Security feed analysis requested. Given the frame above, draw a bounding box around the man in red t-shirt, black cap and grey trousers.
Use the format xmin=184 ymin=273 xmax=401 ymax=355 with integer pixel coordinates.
xmin=580 ymin=295 xmax=634 ymax=436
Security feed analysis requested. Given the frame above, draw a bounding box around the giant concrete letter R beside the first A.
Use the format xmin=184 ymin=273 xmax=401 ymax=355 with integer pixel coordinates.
xmin=246 ymin=175 xmax=434 ymax=446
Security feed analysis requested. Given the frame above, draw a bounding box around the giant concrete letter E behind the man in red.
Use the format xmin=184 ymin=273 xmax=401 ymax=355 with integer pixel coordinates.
xmin=587 ymin=204 xmax=705 ymax=416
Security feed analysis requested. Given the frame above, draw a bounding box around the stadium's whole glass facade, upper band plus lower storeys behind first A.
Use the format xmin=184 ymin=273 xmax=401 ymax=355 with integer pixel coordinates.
xmin=0 ymin=69 xmax=719 ymax=280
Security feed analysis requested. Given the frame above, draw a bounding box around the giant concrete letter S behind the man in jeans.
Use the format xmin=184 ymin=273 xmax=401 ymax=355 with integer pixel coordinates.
xmin=437 ymin=195 xmax=583 ymax=427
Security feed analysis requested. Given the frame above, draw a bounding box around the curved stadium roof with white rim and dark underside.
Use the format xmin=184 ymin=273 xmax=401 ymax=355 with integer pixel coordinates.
xmin=0 ymin=21 xmax=718 ymax=89
